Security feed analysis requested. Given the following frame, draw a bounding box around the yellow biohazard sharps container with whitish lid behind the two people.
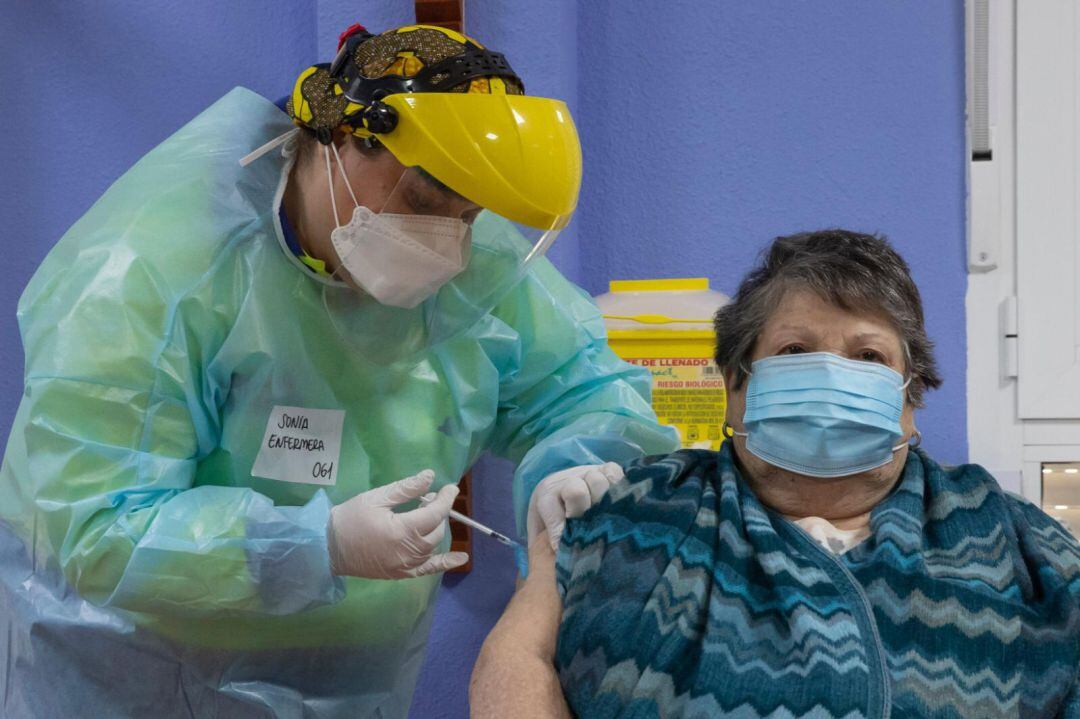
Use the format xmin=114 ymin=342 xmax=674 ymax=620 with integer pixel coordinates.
xmin=596 ymin=277 xmax=730 ymax=449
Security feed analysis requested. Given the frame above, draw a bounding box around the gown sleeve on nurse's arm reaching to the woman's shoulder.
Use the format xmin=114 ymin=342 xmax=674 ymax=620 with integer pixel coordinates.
xmin=492 ymin=259 xmax=678 ymax=531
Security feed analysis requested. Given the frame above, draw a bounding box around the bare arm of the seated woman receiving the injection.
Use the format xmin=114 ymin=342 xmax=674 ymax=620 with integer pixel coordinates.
xmin=469 ymin=532 xmax=570 ymax=719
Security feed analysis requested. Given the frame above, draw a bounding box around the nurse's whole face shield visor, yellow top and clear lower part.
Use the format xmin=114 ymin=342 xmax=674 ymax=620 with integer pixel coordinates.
xmin=325 ymin=93 xmax=581 ymax=363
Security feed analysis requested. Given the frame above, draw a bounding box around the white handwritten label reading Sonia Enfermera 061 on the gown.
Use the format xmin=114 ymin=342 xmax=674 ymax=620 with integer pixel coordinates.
xmin=252 ymin=406 xmax=345 ymax=485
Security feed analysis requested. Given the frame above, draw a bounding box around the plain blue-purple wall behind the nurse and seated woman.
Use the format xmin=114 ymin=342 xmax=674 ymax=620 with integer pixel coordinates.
xmin=0 ymin=0 xmax=967 ymax=718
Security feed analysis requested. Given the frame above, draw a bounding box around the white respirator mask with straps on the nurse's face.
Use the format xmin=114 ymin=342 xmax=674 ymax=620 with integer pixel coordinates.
xmin=324 ymin=145 xmax=470 ymax=310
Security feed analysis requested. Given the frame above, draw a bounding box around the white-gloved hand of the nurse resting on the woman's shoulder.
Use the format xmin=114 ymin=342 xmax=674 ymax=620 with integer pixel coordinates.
xmin=526 ymin=462 xmax=624 ymax=550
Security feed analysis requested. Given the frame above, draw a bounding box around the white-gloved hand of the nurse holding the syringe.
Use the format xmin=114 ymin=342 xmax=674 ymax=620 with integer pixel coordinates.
xmin=326 ymin=470 xmax=469 ymax=579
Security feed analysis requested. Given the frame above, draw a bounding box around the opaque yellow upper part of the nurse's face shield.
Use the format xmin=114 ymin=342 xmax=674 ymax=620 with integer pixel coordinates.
xmin=378 ymin=93 xmax=581 ymax=227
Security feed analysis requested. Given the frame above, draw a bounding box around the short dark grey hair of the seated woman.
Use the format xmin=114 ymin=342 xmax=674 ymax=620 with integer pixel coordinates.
xmin=714 ymin=229 xmax=942 ymax=407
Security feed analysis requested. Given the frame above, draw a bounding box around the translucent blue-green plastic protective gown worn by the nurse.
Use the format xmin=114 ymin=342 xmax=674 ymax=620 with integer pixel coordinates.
xmin=0 ymin=89 xmax=676 ymax=718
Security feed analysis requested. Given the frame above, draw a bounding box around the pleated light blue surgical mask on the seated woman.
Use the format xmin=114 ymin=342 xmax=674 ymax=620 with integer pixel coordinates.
xmin=738 ymin=352 xmax=910 ymax=477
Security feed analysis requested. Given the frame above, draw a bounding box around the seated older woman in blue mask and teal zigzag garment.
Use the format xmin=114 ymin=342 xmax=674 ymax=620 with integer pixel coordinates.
xmin=471 ymin=230 xmax=1080 ymax=719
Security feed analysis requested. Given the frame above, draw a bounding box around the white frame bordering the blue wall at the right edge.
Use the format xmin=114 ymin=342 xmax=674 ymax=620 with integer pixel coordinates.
xmin=966 ymin=0 xmax=1080 ymax=503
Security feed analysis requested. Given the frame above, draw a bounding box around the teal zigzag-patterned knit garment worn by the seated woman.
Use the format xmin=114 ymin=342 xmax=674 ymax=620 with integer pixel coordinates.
xmin=556 ymin=443 xmax=1080 ymax=719
